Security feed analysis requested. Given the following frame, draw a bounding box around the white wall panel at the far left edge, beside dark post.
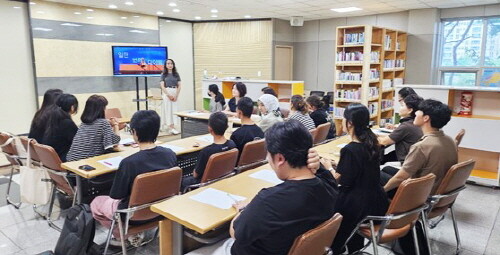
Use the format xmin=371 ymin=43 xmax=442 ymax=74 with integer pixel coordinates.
xmin=0 ymin=1 xmax=37 ymax=134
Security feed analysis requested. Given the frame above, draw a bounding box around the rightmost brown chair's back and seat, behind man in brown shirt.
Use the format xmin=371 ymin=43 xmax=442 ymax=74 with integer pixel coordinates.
xmin=432 ymin=159 xmax=476 ymax=218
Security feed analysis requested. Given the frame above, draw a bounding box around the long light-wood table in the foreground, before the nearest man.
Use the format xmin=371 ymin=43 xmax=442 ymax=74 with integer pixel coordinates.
xmin=151 ymin=136 xmax=350 ymax=255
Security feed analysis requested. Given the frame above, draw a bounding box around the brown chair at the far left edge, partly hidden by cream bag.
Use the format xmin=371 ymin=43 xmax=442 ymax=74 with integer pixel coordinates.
xmin=0 ymin=132 xmax=23 ymax=209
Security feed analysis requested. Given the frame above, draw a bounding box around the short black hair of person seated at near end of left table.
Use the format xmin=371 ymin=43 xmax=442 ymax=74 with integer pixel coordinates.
xmin=130 ymin=110 xmax=160 ymax=143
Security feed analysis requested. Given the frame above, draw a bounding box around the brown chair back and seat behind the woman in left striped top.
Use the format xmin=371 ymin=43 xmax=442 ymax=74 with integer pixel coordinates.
xmin=33 ymin=143 xmax=73 ymax=195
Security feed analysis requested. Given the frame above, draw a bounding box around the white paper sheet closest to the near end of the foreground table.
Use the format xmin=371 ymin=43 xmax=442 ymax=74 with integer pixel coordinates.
xmin=189 ymin=188 xmax=246 ymax=209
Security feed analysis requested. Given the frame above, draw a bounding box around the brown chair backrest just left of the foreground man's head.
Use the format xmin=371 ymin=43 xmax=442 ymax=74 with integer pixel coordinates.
xmin=236 ymin=139 xmax=267 ymax=173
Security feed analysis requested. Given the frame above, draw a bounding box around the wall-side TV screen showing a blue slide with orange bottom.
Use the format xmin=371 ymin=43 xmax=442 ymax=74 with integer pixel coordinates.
xmin=112 ymin=46 xmax=168 ymax=76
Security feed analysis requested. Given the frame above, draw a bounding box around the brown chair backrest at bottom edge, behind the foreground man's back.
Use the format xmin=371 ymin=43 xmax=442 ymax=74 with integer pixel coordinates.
xmin=288 ymin=213 xmax=342 ymax=255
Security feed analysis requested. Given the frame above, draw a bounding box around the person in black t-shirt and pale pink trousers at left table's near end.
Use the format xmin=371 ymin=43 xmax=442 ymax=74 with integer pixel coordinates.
xmin=90 ymin=110 xmax=177 ymax=246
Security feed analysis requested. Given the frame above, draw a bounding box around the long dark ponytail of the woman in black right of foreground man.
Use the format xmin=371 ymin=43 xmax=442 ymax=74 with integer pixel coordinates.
xmin=344 ymin=104 xmax=380 ymax=161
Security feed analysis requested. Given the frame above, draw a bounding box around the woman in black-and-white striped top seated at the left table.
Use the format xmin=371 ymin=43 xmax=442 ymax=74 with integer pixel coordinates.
xmin=67 ymin=95 xmax=120 ymax=161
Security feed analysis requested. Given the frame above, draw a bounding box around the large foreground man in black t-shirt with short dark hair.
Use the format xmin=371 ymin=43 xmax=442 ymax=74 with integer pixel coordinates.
xmin=190 ymin=120 xmax=337 ymax=255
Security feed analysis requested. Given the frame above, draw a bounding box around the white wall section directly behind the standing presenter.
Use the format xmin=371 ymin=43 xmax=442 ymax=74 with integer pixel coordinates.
xmin=159 ymin=19 xmax=195 ymax=111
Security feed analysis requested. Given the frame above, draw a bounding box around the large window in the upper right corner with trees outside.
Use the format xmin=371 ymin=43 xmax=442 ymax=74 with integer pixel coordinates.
xmin=439 ymin=17 xmax=500 ymax=87
